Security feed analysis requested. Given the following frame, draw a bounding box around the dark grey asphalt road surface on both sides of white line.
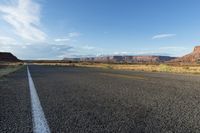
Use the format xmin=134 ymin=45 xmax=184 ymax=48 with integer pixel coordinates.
xmin=0 ymin=66 xmax=200 ymax=133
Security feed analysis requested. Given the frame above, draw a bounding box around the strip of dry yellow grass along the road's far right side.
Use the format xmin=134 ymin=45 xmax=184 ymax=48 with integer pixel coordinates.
xmin=30 ymin=62 xmax=200 ymax=74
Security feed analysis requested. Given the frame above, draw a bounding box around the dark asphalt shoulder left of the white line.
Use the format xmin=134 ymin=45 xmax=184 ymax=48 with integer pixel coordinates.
xmin=0 ymin=67 xmax=32 ymax=133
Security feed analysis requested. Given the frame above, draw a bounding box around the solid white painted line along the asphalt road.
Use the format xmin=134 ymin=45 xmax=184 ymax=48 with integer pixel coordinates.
xmin=27 ymin=66 xmax=50 ymax=133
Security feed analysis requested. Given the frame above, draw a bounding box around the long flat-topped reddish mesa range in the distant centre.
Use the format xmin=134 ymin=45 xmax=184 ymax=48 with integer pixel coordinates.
xmin=63 ymin=56 xmax=176 ymax=63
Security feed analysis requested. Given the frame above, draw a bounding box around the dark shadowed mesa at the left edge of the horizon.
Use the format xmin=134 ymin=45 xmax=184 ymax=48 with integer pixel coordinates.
xmin=0 ymin=52 xmax=20 ymax=62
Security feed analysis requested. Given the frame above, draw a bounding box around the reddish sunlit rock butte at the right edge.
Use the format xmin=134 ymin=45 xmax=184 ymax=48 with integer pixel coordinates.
xmin=172 ymin=46 xmax=200 ymax=64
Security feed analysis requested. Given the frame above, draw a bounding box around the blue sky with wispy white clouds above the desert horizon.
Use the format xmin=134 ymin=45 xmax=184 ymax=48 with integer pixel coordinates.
xmin=0 ymin=0 xmax=200 ymax=59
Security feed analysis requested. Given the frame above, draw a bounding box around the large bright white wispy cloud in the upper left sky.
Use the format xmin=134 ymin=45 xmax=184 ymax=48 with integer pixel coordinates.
xmin=0 ymin=0 xmax=46 ymax=42
